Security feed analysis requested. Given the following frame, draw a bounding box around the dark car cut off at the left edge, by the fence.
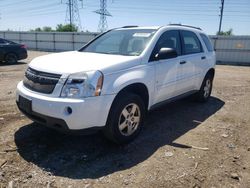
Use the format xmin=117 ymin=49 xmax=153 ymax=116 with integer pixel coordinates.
xmin=0 ymin=38 xmax=28 ymax=64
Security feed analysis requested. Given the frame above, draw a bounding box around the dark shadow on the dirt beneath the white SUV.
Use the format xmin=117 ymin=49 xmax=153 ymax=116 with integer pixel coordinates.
xmin=15 ymin=97 xmax=224 ymax=179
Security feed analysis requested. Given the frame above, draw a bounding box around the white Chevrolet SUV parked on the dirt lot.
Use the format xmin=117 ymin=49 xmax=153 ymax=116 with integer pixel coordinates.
xmin=16 ymin=25 xmax=215 ymax=143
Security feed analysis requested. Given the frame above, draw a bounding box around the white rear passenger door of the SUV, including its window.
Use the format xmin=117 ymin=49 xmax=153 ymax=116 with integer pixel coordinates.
xmin=177 ymin=30 xmax=204 ymax=94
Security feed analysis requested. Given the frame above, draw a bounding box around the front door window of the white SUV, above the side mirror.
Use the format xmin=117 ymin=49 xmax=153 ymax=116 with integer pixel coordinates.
xmin=150 ymin=30 xmax=181 ymax=61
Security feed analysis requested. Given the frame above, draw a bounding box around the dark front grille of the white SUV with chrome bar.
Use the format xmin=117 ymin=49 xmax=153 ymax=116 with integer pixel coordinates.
xmin=23 ymin=67 xmax=61 ymax=94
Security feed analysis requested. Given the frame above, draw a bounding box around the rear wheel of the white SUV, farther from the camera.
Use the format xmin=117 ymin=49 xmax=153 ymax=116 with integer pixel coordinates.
xmin=195 ymin=74 xmax=213 ymax=102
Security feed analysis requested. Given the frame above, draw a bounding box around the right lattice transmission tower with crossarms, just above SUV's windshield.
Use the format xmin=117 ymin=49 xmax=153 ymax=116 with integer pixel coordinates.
xmin=94 ymin=0 xmax=112 ymax=32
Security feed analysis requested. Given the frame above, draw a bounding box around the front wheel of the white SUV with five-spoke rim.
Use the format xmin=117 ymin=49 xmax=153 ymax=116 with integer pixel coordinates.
xmin=104 ymin=93 xmax=146 ymax=144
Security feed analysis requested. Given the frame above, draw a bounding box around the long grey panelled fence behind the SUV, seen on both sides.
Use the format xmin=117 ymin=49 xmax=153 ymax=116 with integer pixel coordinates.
xmin=0 ymin=31 xmax=250 ymax=65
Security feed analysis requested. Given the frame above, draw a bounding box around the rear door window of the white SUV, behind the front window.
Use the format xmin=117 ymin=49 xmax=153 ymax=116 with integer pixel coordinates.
xmin=181 ymin=31 xmax=203 ymax=54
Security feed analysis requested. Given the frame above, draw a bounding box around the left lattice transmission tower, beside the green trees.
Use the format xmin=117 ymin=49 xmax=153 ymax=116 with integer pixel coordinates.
xmin=62 ymin=0 xmax=82 ymax=31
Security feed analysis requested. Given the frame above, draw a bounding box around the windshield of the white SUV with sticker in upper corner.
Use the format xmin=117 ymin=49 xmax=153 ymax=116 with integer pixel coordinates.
xmin=80 ymin=29 xmax=156 ymax=56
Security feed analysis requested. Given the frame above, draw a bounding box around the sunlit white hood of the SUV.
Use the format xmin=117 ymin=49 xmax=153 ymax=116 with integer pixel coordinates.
xmin=29 ymin=51 xmax=140 ymax=74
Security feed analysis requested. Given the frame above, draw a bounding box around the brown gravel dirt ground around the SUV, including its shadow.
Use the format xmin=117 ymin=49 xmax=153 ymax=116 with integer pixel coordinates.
xmin=0 ymin=51 xmax=250 ymax=188
